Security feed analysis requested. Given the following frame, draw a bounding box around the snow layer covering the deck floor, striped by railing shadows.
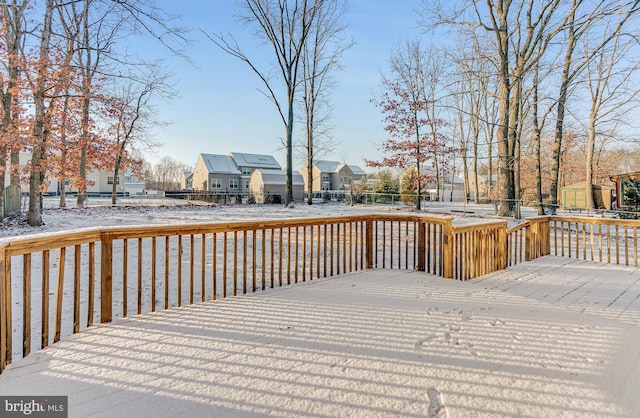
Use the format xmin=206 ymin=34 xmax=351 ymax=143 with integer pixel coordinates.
xmin=0 ymin=257 xmax=640 ymax=417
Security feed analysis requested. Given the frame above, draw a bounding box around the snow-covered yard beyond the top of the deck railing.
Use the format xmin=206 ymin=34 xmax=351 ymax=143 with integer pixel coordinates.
xmin=0 ymin=196 xmax=535 ymax=240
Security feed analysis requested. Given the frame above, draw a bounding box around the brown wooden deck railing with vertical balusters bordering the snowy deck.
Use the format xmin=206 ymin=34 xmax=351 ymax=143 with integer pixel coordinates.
xmin=0 ymin=214 xmax=640 ymax=372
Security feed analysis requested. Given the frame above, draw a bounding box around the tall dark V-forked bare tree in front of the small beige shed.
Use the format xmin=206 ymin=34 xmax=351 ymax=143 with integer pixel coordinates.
xmin=207 ymin=0 xmax=324 ymax=204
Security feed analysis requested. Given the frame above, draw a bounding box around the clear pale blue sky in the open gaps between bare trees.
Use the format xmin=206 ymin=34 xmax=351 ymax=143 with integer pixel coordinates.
xmin=142 ymin=0 xmax=428 ymax=168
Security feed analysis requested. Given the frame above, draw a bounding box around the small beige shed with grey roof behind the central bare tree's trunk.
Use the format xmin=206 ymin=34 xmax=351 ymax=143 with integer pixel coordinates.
xmin=249 ymin=169 xmax=304 ymax=203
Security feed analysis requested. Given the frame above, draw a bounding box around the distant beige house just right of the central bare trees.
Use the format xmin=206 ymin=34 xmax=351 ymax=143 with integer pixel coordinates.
xmin=300 ymin=160 xmax=367 ymax=192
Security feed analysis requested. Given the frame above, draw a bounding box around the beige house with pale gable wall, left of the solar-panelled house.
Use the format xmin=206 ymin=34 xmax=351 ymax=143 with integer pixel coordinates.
xmin=192 ymin=154 xmax=241 ymax=192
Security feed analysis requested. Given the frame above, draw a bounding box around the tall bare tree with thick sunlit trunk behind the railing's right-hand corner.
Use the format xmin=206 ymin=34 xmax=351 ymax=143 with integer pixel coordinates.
xmin=422 ymin=0 xmax=562 ymax=216
